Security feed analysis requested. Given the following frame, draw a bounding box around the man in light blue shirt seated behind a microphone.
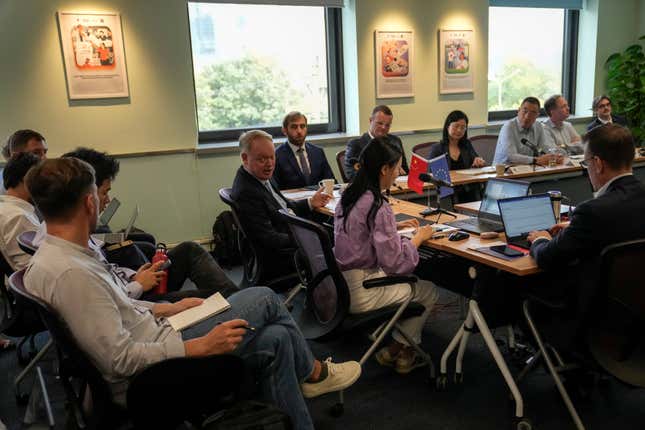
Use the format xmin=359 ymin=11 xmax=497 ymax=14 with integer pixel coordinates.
xmin=493 ymin=97 xmax=562 ymax=166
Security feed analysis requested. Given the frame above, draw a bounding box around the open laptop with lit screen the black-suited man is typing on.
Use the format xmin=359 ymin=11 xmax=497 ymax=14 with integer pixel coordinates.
xmin=497 ymin=194 xmax=555 ymax=249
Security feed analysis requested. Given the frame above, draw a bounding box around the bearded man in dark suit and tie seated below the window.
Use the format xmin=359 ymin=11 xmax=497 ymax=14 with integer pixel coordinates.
xmin=273 ymin=112 xmax=336 ymax=190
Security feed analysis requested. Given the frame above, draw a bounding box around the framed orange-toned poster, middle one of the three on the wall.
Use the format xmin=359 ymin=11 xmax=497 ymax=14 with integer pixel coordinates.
xmin=374 ymin=30 xmax=414 ymax=99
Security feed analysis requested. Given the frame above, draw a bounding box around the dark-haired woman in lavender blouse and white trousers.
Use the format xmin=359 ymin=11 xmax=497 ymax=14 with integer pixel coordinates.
xmin=334 ymin=137 xmax=437 ymax=373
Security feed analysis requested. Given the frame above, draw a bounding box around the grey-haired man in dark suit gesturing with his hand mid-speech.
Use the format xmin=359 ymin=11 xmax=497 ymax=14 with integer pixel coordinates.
xmin=231 ymin=130 xmax=331 ymax=282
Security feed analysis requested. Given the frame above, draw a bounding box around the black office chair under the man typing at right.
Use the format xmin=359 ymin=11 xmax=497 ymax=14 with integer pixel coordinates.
xmin=518 ymin=239 xmax=645 ymax=429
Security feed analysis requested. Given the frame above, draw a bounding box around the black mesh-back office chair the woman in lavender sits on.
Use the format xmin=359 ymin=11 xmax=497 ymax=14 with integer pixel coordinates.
xmin=280 ymin=209 xmax=435 ymax=416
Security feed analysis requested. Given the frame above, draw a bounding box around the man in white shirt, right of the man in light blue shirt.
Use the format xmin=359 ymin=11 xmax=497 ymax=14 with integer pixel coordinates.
xmin=542 ymin=94 xmax=584 ymax=155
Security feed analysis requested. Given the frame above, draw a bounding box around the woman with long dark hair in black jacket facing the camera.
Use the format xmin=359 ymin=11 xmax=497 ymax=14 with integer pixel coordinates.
xmin=429 ymin=110 xmax=486 ymax=203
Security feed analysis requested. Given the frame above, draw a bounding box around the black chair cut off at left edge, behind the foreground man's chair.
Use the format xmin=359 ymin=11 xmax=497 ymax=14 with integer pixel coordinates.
xmin=0 ymin=254 xmax=52 ymax=403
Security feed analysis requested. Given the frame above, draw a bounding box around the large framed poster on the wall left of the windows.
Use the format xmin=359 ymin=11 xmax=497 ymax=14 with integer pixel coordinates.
xmin=58 ymin=12 xmax=130 ymax=99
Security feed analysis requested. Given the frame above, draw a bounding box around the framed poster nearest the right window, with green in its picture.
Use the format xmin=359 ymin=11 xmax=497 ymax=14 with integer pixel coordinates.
xmin=439 ymin=30 xmax=474 ymax=94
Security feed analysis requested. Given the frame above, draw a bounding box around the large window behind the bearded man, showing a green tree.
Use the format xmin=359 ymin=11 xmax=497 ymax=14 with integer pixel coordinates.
xmin=188 ymin=2 xmax=342 ymax=142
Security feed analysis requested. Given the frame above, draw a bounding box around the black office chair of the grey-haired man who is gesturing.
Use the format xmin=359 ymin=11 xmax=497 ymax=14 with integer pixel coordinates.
xmin=219 ymin=188 xmax=300 ymax=291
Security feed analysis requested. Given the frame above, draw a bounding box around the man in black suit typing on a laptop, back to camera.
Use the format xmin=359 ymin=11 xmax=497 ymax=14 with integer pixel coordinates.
xmin=528 ymin=124 xmax=645 ymax=344
